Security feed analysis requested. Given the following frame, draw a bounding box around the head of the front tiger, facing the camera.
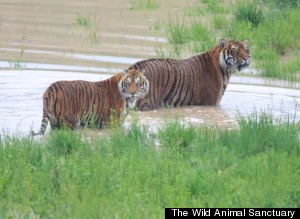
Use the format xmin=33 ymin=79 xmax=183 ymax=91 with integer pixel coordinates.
xmin=118 ymin=69 xmax=149 ymax=109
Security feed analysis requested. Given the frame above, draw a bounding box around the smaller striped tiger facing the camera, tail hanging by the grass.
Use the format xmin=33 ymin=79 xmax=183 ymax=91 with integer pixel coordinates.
xmin=33 ymin=70 xmax=149 ymax=135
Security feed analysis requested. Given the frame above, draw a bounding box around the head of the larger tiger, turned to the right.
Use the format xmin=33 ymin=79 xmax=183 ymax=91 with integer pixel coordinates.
xmin=219 ymin=39 xmax=251 ymax=73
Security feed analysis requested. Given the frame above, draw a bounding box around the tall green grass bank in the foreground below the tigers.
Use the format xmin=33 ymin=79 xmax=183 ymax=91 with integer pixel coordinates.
xmin=0 ymin=115 xmax=300 ymax=218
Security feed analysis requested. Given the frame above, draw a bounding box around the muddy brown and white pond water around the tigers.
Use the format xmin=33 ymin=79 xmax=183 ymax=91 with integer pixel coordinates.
xmin=0 ymin=0 xmax=300 ymax=133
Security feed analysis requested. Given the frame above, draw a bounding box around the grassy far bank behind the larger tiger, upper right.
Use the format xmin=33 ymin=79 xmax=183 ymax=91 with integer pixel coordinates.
xmin=152 ymin=0 xmax=300 ymax=81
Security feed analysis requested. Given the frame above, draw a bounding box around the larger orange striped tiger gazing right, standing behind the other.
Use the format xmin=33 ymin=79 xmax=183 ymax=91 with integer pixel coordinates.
xmin=128 ymin=39 xmax=251 ymax=111
